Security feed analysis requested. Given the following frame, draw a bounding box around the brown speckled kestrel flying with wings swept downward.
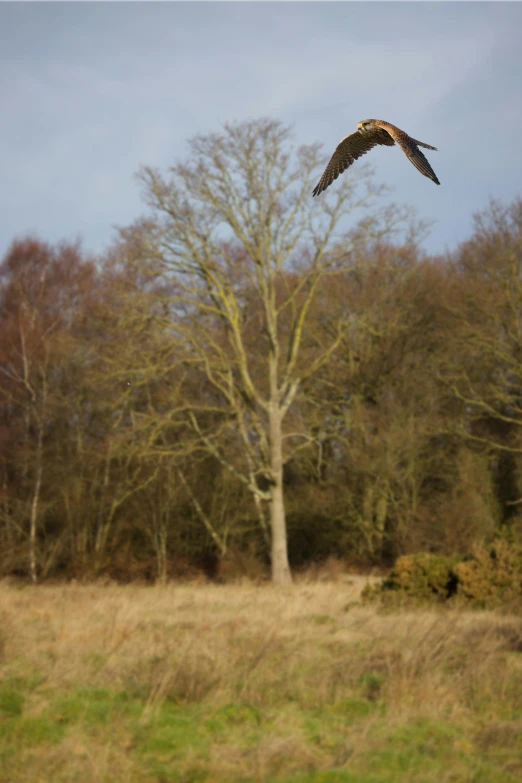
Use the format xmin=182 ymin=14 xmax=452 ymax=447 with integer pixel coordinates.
xmin=313 ymin=120 xmax=440 ymax=196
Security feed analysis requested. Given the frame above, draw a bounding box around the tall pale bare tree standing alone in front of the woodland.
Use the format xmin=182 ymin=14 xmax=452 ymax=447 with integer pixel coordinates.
xmin=118 ymin=120 xmax=406 ymax=585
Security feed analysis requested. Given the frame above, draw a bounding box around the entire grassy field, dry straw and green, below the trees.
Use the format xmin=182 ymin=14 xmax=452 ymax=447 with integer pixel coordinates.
xmin=0 ymin=579 xmax=522 ymax=783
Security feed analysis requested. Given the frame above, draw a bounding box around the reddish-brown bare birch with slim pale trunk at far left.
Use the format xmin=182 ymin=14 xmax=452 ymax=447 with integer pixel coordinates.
xmin=0 ymin=239 xmax=92 ymax=582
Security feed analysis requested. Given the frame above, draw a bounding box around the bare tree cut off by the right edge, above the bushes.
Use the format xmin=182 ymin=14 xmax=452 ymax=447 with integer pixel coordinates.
xmin=443 ymin=199 xmax=522 ymax=453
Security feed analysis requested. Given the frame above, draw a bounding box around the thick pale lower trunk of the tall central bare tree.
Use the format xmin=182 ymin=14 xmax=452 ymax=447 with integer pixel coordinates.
xmin=269 ymin=396 xmax=292 ymax=586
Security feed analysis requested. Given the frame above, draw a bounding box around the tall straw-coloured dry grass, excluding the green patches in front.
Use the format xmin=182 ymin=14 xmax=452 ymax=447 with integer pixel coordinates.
xmin=0 ymin=579 xmax=522 ymax=780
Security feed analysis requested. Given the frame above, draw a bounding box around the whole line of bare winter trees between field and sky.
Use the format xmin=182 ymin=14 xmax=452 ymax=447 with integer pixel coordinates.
xmin=0 ymin=121 xmax=522 ymax=583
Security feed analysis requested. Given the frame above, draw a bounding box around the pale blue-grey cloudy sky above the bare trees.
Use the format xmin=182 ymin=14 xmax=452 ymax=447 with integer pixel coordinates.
xmin=0 ymin=2 xmax=522 ymax=262
